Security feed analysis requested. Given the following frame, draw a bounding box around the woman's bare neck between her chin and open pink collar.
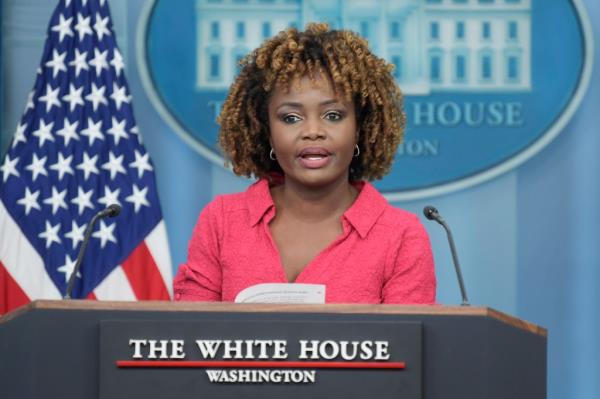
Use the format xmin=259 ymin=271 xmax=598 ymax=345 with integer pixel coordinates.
xmin=271 ymin=177 xmax=358 ymax=221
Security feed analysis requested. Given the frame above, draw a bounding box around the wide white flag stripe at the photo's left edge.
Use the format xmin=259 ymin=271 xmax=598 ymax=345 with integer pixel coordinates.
xmin=0 ymin=201 xmax=62 ymax=299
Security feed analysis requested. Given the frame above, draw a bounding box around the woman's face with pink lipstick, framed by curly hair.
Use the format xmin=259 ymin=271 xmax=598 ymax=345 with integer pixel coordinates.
xmin=268 ymin=75 xmax=357 ymax=191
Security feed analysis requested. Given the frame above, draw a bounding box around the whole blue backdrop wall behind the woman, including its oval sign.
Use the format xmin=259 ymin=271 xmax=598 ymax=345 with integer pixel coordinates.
xmin=0 ymin=0 xmax=600 ymax=399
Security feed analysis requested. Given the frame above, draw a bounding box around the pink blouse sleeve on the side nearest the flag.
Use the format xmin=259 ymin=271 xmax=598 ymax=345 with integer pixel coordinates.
xmin=173 ymin=197 xmax=223 ymax=301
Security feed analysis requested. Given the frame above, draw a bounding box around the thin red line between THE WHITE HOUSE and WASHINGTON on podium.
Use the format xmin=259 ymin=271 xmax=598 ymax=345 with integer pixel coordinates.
xmin=117 ymin=360 xmax=406 ymax=369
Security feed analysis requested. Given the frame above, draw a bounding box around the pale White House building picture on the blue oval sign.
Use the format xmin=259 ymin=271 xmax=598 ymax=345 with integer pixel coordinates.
xmin=196 ymin=0 xmax=531 ymax=95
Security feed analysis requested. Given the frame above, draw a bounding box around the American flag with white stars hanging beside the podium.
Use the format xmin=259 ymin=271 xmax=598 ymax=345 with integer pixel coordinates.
xmin=0 ymin=0 xmax=172 ymax=314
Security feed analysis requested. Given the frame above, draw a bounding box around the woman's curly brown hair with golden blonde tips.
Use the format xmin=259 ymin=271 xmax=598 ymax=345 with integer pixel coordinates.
xmin=218 ymin=23 xmax=406 ymax=181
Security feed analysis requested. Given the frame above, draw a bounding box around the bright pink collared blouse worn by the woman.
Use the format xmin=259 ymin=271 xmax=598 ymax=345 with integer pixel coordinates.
xmin=174 ymin=180 xmax=436 ymax=304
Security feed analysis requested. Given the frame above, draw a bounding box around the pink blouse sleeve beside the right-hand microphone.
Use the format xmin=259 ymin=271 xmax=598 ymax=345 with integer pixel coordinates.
xmin=382 ymin=215 xmax=436 ymax=304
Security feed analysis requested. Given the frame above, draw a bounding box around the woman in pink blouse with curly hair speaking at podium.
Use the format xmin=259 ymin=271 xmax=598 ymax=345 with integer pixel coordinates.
xmin=174 ymin=24 xmax=435 ymax=303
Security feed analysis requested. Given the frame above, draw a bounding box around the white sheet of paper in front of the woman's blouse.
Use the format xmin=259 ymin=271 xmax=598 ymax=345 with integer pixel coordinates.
xmin=235 ymin=283 xmax=325 ymax=303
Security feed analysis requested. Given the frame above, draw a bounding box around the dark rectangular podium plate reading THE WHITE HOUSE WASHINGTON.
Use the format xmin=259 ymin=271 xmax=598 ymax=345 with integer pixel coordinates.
xmin=100 ymin=322 xmax=422 ymax=399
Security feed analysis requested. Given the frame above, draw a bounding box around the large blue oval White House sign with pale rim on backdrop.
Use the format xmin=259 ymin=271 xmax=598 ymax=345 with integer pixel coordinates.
xmin=143 ymin=0 xmax=591 ymax=199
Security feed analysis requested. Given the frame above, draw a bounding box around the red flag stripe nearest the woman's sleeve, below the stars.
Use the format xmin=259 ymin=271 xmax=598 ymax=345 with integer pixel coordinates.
xmin=121 ymin=241 xmax=170 ymax=300
